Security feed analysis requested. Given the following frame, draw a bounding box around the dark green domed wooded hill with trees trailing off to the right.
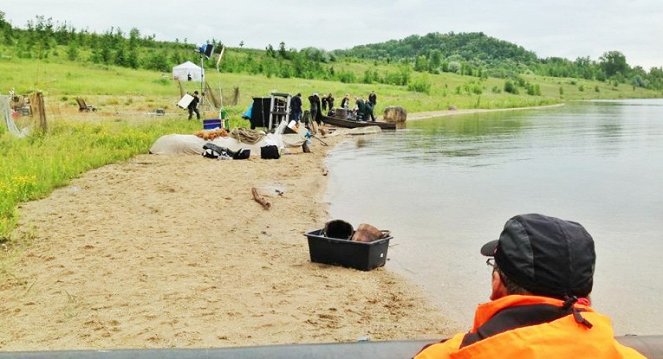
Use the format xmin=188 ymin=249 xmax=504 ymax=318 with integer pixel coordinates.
xmin=335 ymin=32 xmax=663 ymax=89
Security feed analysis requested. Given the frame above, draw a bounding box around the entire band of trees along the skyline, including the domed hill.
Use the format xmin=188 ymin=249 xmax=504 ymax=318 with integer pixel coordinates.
xmin=0 ymin=11 xmax=663 ymax=90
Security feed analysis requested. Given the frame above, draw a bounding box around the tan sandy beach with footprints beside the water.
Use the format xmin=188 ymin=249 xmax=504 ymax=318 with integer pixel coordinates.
xmin=0 ymin=124 xmax=460 ymax=351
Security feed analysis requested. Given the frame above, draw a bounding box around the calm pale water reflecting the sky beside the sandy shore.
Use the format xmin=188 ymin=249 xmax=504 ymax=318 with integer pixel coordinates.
xmin=327 ymin=100 xmax=663 ymax=335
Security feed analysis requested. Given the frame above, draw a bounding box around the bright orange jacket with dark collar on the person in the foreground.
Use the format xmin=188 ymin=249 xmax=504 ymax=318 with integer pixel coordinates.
xmin=415 ymin=295 xmax=644 ymax=359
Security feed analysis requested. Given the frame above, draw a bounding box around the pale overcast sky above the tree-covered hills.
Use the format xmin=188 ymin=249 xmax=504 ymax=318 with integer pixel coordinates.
xmin=0 ymin=0 xmax=663 ymax=70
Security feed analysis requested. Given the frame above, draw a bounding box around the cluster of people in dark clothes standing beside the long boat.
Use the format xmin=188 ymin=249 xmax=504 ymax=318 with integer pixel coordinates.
xmin=290 ymin=91 xmax=377 ymax=124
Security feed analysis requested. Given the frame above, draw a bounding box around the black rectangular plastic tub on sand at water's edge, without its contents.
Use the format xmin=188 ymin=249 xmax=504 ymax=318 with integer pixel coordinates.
xmin=306 ymin=229 xmax=392 ymax=271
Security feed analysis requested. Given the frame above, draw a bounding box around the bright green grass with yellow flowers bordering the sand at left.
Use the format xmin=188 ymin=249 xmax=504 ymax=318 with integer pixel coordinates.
xmin=0 ymin=119 xmax=199 ymax=241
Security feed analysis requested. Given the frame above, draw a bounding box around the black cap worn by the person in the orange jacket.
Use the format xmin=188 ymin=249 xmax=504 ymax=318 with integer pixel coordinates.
xmin=481 ymin=213 xmax=596 ymax=299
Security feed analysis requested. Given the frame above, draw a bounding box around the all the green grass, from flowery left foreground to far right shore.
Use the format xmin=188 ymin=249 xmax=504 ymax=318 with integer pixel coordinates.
xmin=0 ymin=58 xmax=663 ymax=242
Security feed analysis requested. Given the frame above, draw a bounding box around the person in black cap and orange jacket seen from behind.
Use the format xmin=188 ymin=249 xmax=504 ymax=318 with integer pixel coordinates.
xmin=415 ymin=214 xmax=644 ymax=359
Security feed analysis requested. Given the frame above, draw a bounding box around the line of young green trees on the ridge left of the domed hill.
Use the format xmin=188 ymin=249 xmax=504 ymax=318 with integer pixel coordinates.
xmin=0 ymin=11 xmax=418 ymax=85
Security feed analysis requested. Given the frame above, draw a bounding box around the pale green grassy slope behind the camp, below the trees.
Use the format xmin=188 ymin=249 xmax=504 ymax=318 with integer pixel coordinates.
xmin=0 ymin=54 xmax=661 ymax=119
